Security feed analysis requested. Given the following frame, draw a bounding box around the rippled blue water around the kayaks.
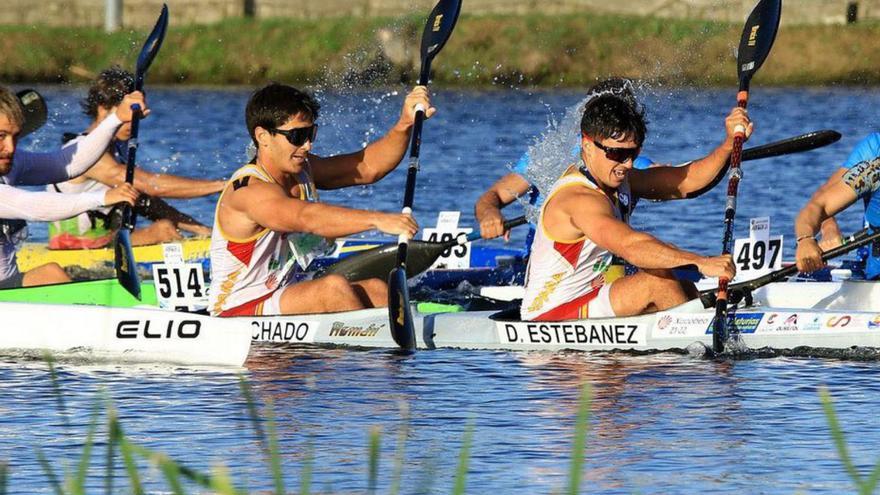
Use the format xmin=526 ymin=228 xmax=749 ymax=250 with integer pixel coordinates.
xmin=0 ymin=87 xmax=880 ymax=494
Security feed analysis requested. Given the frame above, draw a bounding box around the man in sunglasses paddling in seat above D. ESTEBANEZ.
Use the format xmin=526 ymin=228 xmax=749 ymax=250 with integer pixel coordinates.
xmin=521 ymin=90 xmax=752 ymax=321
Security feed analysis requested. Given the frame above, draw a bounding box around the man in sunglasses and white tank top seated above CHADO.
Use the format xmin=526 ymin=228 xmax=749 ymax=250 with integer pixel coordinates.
xmin=208 ymin=80 xmax=424 ymax=316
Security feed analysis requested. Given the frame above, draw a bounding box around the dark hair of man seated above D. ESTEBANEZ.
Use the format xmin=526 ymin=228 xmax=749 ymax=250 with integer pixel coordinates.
xmin=581 ymin=94 xmax=648 ymax=146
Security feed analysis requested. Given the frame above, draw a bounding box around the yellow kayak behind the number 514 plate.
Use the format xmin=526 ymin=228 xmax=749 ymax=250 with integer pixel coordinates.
xmin=16 ymin=238 xmax=211 ymax=271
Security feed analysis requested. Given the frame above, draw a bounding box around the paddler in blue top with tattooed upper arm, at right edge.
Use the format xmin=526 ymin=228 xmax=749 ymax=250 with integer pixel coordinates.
xmin=794 ymin=142 xmax=880 ymax=280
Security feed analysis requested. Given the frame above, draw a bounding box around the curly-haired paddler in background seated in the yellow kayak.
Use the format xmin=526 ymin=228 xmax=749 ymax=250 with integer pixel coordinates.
xmin=46 ymin=67 xmax=225 ymax=249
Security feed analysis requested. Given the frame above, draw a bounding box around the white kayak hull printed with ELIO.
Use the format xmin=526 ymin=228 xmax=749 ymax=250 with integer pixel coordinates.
xmin=0 ymin=302 xmax=251 ymax=366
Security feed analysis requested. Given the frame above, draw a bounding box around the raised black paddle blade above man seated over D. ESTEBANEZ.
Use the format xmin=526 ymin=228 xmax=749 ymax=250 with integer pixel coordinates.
xmin=736 ymin=0 xmax=782 ymax=91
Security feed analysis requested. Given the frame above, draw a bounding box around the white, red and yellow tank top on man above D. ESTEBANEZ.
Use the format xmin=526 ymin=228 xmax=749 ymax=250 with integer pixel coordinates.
xmin=520 ymin=171 xmax=632 ymax=320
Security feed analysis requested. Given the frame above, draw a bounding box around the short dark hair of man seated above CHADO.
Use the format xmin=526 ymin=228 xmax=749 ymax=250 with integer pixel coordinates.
xmin=244 ymin=83 xmax=321 ymax=144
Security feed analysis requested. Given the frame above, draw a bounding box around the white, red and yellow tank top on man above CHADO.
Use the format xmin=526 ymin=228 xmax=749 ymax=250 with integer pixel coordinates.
xmin=208 ymin=164 xmax=333 ymax=315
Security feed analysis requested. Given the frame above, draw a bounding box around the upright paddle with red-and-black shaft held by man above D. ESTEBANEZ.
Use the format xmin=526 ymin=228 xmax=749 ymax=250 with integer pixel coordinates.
xmin=712 ymin=0 xmax=782 ymax=353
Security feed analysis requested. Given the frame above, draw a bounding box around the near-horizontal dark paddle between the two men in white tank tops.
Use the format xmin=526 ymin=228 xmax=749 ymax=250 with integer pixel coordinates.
xmin=320 ymin=216 xmax=527 ymax=281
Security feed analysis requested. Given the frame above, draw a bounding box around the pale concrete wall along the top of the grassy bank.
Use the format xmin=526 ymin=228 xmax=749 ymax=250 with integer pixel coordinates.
xmin=0 ymin=0 xmax=880 ymax=27
